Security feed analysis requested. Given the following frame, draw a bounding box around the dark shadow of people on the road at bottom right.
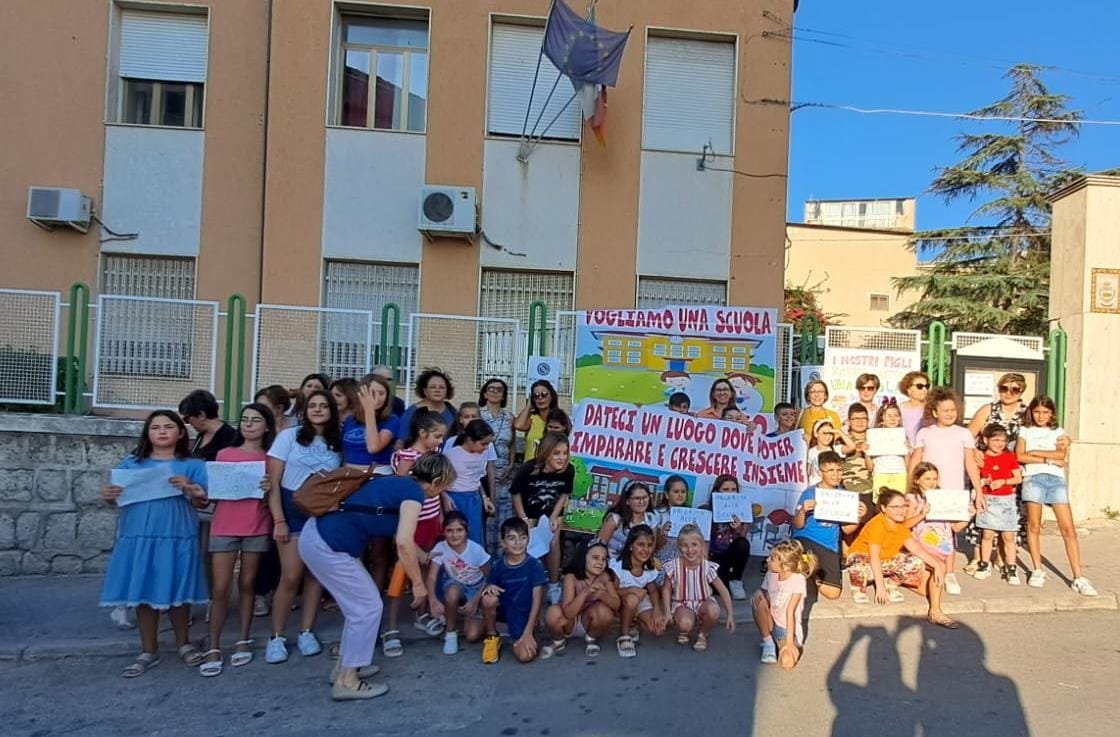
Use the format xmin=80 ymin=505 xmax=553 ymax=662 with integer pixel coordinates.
xmin=828 ymin=618 xmax=1030 ymax=737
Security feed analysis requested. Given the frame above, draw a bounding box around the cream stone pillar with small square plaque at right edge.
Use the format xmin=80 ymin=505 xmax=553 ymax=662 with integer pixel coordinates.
xmin=1049 ymin=171 xmax=1120 ymax=520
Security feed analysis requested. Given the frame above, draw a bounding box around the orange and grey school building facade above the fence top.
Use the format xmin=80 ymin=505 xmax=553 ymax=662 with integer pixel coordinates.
xmin=0 ymin=0 xmax=795 ymax=321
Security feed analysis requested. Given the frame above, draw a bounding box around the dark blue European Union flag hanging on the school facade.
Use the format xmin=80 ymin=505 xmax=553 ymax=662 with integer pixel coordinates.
xmin=544 ymin=0 xmax=629 ymax=87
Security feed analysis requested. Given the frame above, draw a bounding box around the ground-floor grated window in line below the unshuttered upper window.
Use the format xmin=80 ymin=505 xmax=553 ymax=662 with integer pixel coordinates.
xmin=321 ymin=261 xmax=420 ymax=375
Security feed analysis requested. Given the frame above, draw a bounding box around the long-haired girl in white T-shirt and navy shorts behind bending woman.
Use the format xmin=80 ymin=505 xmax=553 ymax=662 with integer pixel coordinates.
xmin=264 ymin=390 xmax=342 ymax=663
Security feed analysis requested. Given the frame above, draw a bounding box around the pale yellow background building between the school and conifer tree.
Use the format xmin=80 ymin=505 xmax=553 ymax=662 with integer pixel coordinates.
xmin=785 ymin=197 xmax=920 ymax=327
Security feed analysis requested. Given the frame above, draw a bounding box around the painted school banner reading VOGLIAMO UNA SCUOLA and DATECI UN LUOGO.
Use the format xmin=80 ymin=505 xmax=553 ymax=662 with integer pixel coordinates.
xmin=564 ymin=307 xmax=805 ymax=550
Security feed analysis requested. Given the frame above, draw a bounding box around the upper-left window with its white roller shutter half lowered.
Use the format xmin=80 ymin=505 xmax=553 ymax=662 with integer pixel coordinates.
xmin=116 ymin=9 xmax=208 ymax=128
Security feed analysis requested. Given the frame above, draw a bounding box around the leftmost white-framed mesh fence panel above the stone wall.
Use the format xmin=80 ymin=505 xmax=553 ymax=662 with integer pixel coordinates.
xmin=0 ymin=289 xmax=62 ymax=404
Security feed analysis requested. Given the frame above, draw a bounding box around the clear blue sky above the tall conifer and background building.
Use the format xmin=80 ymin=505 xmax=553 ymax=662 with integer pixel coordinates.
xmin=788 ymin=0 xmax=1120 ymax=235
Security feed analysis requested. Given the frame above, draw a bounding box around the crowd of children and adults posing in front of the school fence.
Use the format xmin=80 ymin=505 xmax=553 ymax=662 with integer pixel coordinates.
xmin=94 ymin=369 xmax=1095 ymax=700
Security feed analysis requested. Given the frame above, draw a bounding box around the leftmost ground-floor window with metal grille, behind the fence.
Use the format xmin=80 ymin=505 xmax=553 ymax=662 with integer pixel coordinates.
xmin=97 ymin=254 xmax=198 ymax=379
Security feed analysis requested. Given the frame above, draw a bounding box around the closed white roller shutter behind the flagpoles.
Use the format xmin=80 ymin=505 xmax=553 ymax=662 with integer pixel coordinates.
xmin=487 ymin=24 xmax=584 ymax=141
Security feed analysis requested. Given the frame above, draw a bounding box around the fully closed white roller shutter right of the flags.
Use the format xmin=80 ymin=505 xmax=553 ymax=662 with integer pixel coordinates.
xmin=642 ymin=38 xmax=735 ymax=155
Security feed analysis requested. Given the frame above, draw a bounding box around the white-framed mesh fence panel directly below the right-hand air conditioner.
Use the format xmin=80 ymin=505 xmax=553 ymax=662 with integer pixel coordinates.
xmin=405 ymin=312 xmax=525 ymax=401
